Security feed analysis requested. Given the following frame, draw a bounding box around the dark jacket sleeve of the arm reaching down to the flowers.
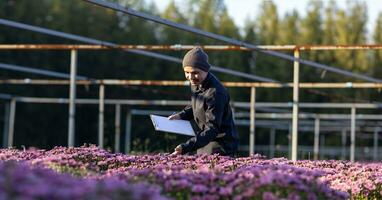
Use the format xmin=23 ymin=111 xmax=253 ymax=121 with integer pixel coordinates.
xmin=181 ymin=93 xmax=226 ymax=154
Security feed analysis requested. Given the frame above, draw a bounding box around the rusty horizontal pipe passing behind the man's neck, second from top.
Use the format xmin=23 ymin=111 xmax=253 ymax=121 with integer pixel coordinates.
xmin=0 ymin=79 xmax=382 ymax=89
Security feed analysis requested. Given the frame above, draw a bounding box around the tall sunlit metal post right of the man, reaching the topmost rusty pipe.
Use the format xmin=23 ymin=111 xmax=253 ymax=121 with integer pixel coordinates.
xmin=292 ymin=48 xmax=300 ymax=161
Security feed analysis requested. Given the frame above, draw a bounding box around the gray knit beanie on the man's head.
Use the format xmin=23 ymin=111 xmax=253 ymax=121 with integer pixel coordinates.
xmin=183 ymin=47 xmax=211 ymax=72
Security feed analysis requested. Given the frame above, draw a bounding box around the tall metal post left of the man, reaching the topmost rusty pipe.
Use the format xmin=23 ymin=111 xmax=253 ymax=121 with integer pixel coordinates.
xmin=68 ymin=49 xmax=77 ymax=147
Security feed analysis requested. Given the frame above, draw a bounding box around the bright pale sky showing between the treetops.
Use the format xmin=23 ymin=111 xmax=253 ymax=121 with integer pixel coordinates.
xmin=152 ymin=0 xmax=382 ymax=41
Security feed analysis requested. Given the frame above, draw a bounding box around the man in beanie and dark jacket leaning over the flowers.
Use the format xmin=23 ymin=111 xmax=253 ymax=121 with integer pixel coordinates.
xmin=168 ymin=47 xmax=238 ymax=157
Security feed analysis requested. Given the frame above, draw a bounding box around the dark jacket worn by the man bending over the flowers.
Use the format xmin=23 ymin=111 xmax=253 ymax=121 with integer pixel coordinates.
xmin=179 ymin=73 xmax=238 ymax=156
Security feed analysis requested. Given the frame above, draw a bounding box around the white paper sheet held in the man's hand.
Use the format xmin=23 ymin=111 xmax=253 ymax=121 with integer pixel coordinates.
xmin=150 ymin=115 xmax=195 ymax=136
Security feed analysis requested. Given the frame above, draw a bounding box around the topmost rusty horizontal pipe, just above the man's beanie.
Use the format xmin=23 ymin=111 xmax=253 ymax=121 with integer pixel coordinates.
xmin=0 ymin=44 xmax=382 ymax=51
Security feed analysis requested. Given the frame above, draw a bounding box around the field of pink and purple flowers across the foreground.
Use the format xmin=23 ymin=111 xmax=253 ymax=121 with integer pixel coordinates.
xmin=0 ymin=146 xmax=382 ymax=200
